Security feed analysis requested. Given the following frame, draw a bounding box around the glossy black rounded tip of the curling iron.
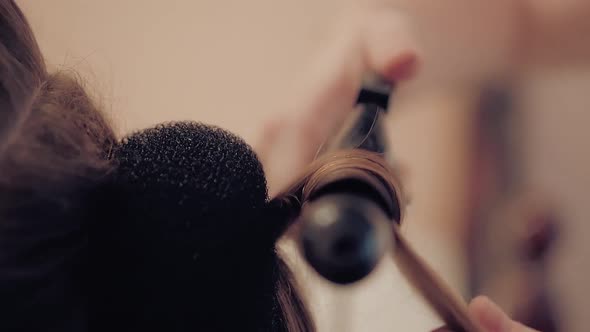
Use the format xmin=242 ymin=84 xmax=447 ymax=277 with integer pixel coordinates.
xmin=301 ymin=193 xmax=391 ymax=284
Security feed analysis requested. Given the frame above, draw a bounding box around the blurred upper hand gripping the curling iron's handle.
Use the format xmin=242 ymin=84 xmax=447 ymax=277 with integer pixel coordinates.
xmin=256 ymin=7 xmax=417 ymax=197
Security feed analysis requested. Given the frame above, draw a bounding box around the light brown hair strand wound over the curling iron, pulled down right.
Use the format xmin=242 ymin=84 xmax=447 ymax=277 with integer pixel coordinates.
xmin=274 ymin=149 xmax=480 ymax=332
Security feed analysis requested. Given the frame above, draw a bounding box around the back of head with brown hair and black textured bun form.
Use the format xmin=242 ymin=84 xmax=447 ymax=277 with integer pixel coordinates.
xmin=0 ymin=0 xmax=312 ymax=331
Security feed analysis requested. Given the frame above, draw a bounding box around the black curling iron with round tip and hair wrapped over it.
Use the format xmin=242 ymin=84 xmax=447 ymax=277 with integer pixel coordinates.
xmin=300 ymin=79 xmax=401 ymax=284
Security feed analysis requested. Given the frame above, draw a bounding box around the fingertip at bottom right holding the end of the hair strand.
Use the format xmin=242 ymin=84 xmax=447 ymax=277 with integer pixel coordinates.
xmin=433 ymin=296 xmax=538 ymax=332
